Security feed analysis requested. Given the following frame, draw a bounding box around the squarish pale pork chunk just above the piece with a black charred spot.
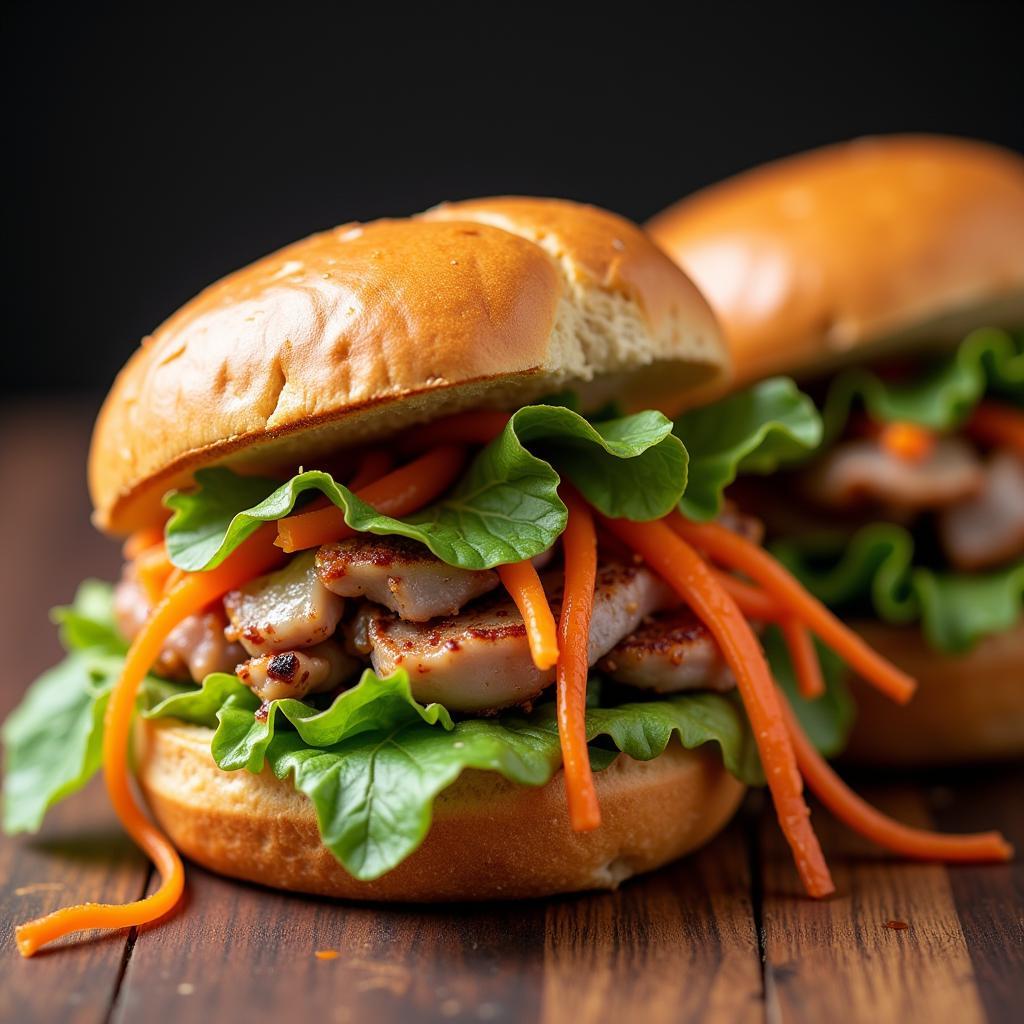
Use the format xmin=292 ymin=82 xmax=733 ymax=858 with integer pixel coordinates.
xmin=224 ymin=551 xmax=345 ymax=657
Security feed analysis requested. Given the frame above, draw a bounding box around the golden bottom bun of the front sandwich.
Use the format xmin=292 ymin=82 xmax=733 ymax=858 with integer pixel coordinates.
xmin=136 ymin=721 xmax=743 ymax=902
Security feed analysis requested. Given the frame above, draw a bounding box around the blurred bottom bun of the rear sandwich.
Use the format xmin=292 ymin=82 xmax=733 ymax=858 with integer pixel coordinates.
xmin=844 ymin=623 xmax=1024 ymax=766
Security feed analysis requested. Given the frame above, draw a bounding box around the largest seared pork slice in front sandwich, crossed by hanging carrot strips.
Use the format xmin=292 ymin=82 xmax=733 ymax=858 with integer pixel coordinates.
xmin=364 ymin=563 xmax=675 ymax=713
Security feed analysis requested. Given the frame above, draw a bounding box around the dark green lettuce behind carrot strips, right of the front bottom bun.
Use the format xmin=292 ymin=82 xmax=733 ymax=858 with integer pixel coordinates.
xmin=763 ymin=627 xmax=856 ymax=758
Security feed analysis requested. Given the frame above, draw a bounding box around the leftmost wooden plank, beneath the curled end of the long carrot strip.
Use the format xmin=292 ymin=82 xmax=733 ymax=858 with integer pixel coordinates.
xmin=0 ymin=403 xmax=150 ymax=1024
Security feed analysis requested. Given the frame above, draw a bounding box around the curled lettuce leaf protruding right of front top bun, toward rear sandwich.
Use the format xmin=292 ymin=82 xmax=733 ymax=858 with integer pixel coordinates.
xmin=674 ymin=377 xmax=821 ymax=521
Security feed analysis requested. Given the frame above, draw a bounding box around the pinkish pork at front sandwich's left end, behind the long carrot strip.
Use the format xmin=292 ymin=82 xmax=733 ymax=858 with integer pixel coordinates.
xmin=114 ymin=566 xmax=246 ymax=683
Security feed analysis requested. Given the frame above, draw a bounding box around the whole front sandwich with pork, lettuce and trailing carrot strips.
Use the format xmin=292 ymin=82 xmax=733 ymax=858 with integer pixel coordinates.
xmin=5 ymin=199 xmax=1010 ymax=955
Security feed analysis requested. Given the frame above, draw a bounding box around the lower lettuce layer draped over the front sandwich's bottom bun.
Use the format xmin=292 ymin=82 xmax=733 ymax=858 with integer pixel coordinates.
xmin=146 ymin=672 xmax=763 ymax=879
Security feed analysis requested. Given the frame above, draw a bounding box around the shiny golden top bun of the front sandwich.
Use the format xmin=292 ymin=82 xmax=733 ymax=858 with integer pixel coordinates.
xmin=89 ymin=198 xmax=728 ymax=534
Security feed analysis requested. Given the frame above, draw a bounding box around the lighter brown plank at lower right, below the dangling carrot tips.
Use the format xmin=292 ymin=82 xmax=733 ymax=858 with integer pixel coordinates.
xmin=761 ymin=783 xmax=985 ymax=1024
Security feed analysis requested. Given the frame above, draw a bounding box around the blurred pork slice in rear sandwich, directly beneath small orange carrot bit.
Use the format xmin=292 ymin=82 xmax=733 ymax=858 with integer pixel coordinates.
xmin=804 ymin=437 xmax=985 ymax=513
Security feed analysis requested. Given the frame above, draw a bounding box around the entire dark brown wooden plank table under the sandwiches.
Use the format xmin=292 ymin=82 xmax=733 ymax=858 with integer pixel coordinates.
xmin=0 ymin=402 xmax=1024 ymax=1024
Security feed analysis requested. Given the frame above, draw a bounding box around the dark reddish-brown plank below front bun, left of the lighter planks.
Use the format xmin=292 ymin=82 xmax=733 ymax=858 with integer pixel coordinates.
xmin=114 ymin=865 xmax=545 ymax=1024
